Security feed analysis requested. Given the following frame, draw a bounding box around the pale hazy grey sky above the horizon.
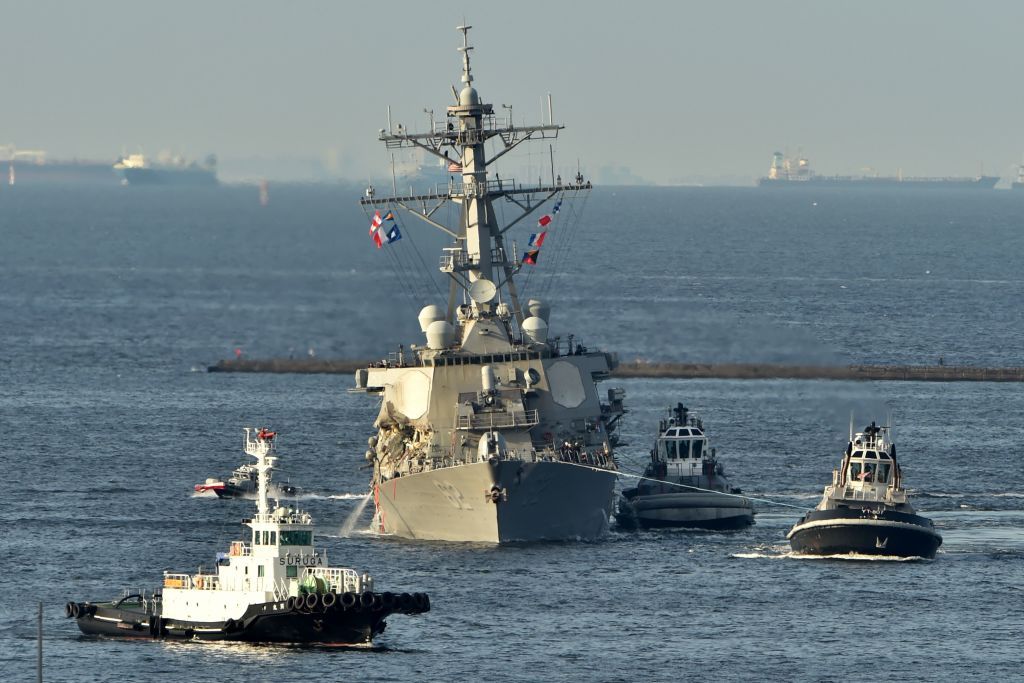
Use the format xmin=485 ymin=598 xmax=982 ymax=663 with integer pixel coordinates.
xmin=0 ymin=0 xmax=1024 ymax=183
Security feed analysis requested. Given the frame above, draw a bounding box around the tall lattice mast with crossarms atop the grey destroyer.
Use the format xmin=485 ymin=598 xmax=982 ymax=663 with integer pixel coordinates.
xmin=360 ymin=26 xmax=590 ymax=325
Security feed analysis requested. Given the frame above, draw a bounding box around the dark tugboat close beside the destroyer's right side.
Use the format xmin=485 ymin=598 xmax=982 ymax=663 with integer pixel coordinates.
xmin=615 ymin=403 xmax=754 ymax=529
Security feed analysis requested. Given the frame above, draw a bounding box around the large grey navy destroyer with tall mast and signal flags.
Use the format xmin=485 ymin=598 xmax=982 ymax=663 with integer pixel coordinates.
xmin=354 ymin=27 xmax=625 ymax=543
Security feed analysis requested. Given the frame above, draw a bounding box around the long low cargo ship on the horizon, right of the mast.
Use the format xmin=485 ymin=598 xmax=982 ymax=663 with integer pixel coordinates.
xmin=758 ymin=152 xmax=999 ymax=189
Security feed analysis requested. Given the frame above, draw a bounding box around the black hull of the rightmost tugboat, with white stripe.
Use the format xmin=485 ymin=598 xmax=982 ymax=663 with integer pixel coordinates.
xmin=786 ymin=515 xmax=942 ymax=559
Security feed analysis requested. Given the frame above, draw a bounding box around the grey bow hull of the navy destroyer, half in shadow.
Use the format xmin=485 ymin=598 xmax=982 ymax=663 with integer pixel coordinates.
xmin=374 ymin=460 xmax=615 ymax=543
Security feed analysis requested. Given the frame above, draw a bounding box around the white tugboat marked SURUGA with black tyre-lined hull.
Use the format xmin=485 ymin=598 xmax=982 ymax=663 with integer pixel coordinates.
xmin=65 ymin=428 xmax=430 ymax=644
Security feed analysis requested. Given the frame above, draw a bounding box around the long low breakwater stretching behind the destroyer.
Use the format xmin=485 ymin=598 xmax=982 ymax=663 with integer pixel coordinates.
xmin=207 ymin=358 xmax=1024 ymax=382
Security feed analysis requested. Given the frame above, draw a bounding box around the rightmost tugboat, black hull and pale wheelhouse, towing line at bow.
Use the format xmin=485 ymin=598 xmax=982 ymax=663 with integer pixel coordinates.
xmin=786 ymin=422 xmax=942 ymax=558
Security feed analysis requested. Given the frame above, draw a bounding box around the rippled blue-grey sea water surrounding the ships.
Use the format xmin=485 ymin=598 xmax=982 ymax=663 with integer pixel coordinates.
xmin=0 ymin=185 xmax=1024 ymax=681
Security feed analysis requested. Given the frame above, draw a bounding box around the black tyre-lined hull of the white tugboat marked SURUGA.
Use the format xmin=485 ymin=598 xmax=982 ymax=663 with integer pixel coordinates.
xmin=66 ymin=593 xmax=430 ymax=645
